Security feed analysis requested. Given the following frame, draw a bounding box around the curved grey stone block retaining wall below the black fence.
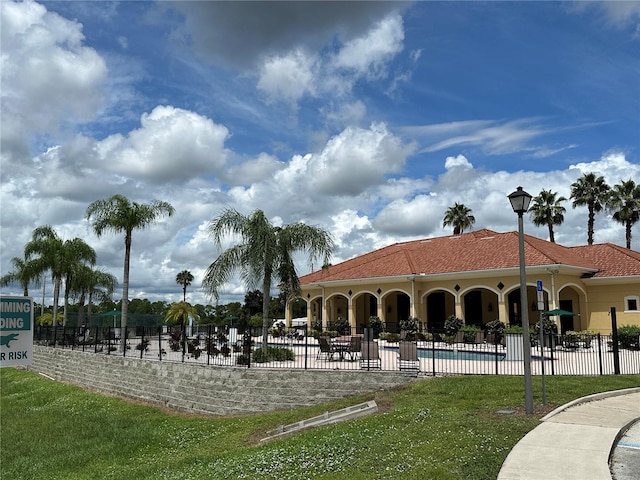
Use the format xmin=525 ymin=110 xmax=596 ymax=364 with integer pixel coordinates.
xmin=30 ymin=345 xmax=417 ymax=415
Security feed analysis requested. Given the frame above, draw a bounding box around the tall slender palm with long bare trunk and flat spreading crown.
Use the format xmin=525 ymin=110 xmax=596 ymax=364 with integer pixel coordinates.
xmin=86 ymin=195 xmax=175 ymax=351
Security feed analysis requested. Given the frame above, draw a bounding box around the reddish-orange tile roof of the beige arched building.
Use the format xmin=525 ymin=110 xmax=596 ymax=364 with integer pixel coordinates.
xmin=300 ymin=229 xmax=640 ymax=285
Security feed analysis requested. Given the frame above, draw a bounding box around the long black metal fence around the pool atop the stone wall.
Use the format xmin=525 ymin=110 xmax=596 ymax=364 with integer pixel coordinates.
xmin=34 ymin=325 xmax=640 ymax=375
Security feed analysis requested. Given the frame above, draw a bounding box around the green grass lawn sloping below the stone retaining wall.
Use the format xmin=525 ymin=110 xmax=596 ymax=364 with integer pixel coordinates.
xmin=0 ymin=368 xmax=640 ymax=480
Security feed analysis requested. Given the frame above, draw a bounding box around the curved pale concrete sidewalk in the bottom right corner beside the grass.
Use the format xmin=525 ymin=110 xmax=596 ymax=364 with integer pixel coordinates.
xmin=498 ymin=388 xmax=640 ymax=480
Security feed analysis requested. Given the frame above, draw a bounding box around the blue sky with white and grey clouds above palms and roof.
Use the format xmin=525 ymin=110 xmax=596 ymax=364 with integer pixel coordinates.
xmin=0 ymin=2 xmax=640 ymax=302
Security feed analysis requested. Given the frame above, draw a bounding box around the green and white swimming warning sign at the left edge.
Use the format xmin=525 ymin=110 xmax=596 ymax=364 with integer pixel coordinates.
xmin=0 ymin=296 xmax=33 ymax=367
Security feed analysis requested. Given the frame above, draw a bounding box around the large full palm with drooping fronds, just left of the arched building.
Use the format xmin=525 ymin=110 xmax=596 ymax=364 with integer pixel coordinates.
xmin=202 ymin=209 xmax=334 ymax=348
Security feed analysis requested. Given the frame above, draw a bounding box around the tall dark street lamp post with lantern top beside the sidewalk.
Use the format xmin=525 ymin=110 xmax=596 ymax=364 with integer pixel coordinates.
xmin=509 ymin=187 xmax=533 ymax=415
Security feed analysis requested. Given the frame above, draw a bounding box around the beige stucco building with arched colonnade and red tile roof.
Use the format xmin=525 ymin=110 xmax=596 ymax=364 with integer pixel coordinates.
xmin=300 ymin=229 xmax=640 ymax=333
